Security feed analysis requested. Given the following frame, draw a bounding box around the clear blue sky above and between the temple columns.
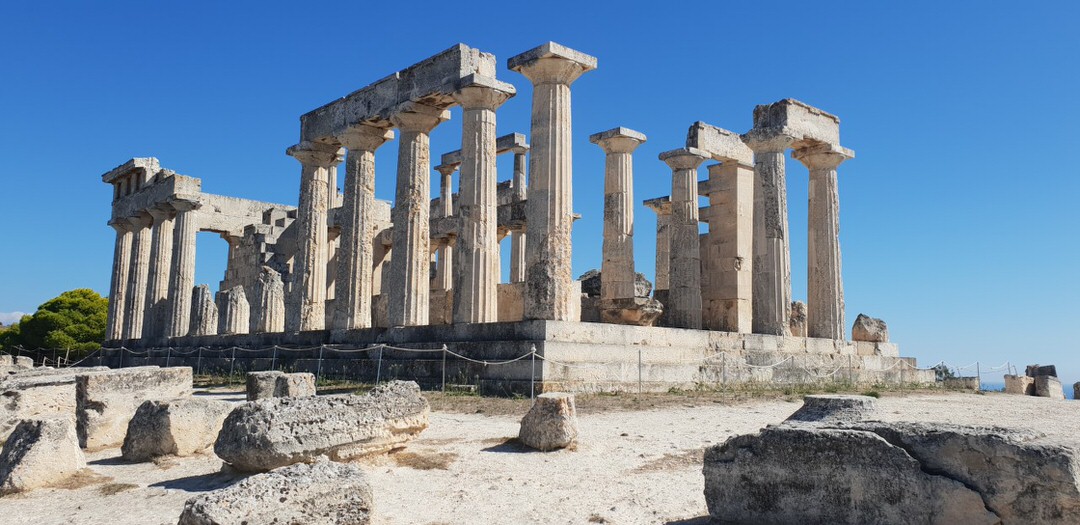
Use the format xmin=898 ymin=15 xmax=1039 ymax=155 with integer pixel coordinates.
xmin=0 ymin=1 xmax=1080 ymax=381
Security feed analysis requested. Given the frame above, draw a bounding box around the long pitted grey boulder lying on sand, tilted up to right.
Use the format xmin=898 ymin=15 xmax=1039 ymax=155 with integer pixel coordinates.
xmin=214 ymin=381 xmax=431 ymax=472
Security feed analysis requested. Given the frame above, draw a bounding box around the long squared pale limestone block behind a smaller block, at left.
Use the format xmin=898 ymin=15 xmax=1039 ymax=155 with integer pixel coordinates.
xmin=76 ymin=366 xmax=191 ymax=450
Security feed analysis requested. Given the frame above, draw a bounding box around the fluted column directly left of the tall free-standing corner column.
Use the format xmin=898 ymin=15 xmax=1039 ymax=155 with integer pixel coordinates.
xmin=453 ymin=77 xmax=514 ymax=323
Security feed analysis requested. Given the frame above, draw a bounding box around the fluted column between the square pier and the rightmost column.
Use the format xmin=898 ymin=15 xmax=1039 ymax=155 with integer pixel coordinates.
xmin=744 ymin=131 xmax=794 ymax=335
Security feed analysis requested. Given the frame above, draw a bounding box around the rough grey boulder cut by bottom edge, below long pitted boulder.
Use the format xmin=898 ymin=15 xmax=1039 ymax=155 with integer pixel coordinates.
xmin=178 ymin=460 xmax=373 ymax=525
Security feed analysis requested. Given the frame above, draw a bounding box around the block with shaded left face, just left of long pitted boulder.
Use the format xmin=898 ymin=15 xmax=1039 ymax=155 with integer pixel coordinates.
xmin=121 ymin=398 xmax=233 ymax=461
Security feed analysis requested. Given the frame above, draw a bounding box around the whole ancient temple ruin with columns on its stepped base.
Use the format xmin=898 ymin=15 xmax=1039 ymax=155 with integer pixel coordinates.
xmin=102 ymin=42 xmax=932 ymax=390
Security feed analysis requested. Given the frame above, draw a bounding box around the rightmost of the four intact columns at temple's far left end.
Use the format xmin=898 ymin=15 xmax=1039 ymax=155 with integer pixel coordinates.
xmin=165 ymin=200 xmax=200 ymax=337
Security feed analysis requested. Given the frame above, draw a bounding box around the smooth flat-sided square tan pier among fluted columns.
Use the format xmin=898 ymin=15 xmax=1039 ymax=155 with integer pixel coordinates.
xmin=701 ymin=159 xmax=754 ymax=334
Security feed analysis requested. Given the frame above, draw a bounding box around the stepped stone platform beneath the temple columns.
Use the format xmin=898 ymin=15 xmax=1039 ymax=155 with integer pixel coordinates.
xmin=97 ymin=321 xmax=934 ymax=395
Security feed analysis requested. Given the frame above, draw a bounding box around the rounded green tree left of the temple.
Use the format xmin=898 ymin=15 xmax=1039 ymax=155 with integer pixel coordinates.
xmin=0 ymin=288 xmax=109 ymax=351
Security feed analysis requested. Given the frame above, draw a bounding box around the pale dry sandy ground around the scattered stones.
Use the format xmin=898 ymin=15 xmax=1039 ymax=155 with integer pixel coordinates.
xmin=0 ymin=386 xmax=1080 ymax=525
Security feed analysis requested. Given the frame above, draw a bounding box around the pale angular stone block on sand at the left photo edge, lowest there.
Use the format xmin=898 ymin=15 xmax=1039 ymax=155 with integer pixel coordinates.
xmin=0 ymin=417 xmax=86 ymax=494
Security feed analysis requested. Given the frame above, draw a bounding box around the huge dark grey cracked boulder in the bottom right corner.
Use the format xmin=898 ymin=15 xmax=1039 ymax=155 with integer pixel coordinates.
xmin=703 ymin=422 xmax=1080 ymax=524
